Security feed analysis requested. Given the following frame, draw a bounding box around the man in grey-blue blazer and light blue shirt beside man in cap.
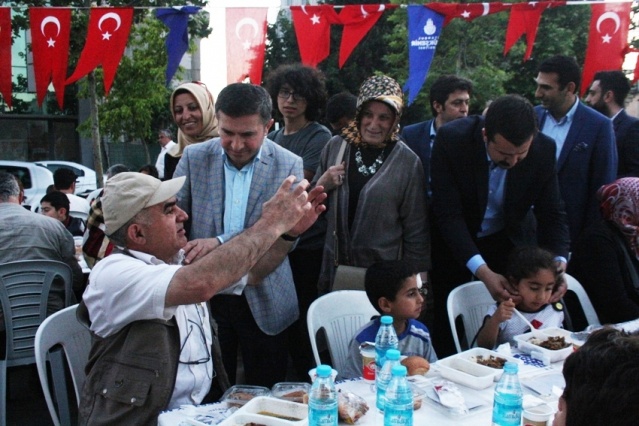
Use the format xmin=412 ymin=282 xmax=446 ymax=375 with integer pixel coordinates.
xmin=175 ymin=83 xmax=304 ymax=387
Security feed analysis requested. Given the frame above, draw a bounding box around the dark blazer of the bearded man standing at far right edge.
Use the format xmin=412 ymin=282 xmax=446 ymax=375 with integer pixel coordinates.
xmin=612 ymin=109 xmax=639 ymax=178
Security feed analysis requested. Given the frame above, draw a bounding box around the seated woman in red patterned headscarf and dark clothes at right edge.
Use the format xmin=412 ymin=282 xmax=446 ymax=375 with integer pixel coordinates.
xmin=568 ymin=177 xmax=639 ymax=324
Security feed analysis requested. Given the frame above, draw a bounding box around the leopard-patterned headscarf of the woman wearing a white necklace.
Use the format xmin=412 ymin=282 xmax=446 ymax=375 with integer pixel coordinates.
xmin=341 ymin=75 xmax=404 ymax=146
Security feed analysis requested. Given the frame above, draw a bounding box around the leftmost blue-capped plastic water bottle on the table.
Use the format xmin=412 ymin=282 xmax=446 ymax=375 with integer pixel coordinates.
xmin=308 ymin=365 xmax=338 ymax=426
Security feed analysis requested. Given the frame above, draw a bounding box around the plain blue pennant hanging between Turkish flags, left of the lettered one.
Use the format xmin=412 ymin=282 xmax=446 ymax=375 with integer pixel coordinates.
xmin=155 ymin=6 xmax=201 ymax=86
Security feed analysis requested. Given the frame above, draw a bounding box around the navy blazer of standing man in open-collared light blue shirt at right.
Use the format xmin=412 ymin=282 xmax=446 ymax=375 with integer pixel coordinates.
xmin=535 ymin=102 xmax=617 ymax=241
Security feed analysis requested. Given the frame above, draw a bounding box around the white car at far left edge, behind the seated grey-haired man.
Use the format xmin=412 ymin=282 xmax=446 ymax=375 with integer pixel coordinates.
xmin=0 ymin=160 xmax=53 ymax=211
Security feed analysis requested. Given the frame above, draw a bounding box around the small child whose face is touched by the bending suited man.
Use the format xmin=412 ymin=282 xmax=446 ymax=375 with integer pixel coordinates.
xmin=477 ymin=247 xmax=564 ymax=349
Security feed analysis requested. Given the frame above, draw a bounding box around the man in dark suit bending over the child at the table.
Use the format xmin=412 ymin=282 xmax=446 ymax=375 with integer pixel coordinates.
xmin=431 ymin=95 xmax=570 ymax=355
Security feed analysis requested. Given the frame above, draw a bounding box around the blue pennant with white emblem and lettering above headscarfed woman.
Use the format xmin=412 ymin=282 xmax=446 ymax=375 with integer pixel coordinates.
xmin=404 ymin=5 xmax=444 ymax=105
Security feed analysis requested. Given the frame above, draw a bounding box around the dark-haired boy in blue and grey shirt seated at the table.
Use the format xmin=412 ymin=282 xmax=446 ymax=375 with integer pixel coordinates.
xmin=339 ymin=260 xmax=437 ymax=378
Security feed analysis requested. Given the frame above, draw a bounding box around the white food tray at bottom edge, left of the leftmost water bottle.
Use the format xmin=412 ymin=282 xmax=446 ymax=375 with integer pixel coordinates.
xmin=219 ymin=396 xmax=308 ymax=426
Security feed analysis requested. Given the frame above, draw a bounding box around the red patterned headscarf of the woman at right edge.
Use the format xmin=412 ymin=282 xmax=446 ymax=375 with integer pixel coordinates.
xmin=597 ymin=177 xmax=639 ymax=259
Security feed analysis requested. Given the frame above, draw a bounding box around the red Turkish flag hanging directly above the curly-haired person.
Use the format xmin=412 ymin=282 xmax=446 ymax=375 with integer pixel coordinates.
xmin=291 ymin=4 xmax=341 ymax=67
